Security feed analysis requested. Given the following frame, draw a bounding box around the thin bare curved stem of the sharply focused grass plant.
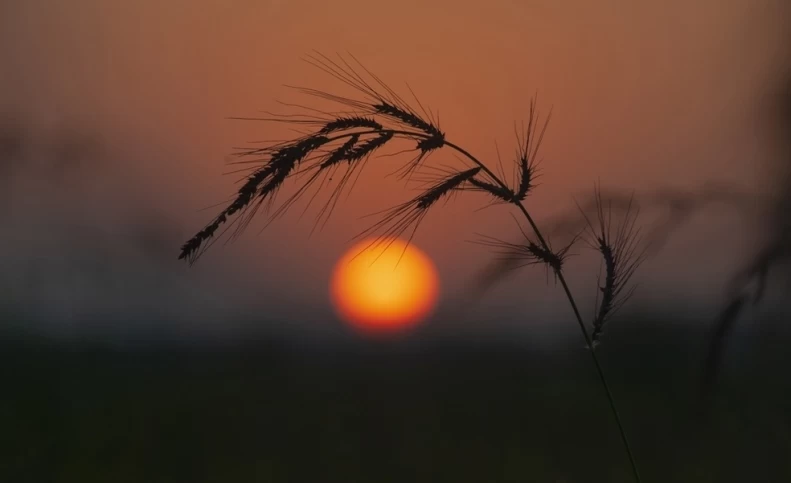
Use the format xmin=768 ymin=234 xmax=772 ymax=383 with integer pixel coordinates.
xmin=445 ymin=137 xmax=641 ymax=483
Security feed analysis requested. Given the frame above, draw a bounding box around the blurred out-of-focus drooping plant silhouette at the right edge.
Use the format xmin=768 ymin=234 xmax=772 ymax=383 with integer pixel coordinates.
xmin=496 ymin=179 xmax=791 ymax=402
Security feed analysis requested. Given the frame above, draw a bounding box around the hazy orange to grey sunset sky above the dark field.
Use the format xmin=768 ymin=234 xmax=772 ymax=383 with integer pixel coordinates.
xmin=0 ymin=0 xmax=787 ymax=335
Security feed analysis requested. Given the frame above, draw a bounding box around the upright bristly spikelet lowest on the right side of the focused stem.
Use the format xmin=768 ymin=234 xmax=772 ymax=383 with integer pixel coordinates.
xmin=585 ymin=188 xmax=645 ymax=347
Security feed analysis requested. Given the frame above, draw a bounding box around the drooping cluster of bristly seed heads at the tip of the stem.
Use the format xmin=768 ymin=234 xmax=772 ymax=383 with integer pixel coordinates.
xmin=179 ymin=53 xmax=468 ymax=263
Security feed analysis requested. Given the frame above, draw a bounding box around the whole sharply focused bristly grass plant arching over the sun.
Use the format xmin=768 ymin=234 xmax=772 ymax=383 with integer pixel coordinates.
xmin=179 ymin=53 xmax=644 ymax=482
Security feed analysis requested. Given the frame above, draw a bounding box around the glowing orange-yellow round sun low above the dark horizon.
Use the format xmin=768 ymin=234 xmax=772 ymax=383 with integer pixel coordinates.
xmin=330 ymin=239 xmax=439 ymax=333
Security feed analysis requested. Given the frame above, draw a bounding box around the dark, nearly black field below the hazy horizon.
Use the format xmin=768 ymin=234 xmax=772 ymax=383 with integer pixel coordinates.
xmin=0 ymin=318 xmax=791 ymax=483
